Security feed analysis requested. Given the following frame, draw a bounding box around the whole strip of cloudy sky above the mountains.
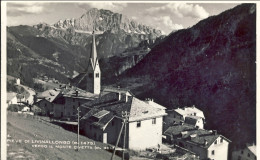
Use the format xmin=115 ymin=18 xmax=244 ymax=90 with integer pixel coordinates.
xmin=6 ymin=1 xmax=239 ymax=34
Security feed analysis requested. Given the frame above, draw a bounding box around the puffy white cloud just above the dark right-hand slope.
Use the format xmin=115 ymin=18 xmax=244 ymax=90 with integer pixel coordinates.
xmin=145 ymin=3 xmax=209 ymax=19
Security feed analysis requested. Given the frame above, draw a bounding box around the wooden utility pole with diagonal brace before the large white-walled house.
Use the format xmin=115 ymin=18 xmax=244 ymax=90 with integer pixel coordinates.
xmin=111 ymin=111 xmax=129 ymax=160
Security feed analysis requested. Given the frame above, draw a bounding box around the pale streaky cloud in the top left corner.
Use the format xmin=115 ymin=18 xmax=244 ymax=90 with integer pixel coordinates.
xmin=7 ymin=2 xmax=47 ymax=17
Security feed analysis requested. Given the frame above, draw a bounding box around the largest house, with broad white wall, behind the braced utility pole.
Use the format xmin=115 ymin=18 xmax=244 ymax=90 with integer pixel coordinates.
xmin=80 ymin=89 xmax=166 ymax=150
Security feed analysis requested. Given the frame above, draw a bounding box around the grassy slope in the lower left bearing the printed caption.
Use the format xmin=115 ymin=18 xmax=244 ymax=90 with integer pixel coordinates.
xmin=7 ymin=112 xmax=120 ymax=160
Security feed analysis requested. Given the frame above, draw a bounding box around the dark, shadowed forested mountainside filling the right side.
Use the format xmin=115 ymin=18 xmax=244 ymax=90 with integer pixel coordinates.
xmin=115 ymin=4 xmax=256 ymax=145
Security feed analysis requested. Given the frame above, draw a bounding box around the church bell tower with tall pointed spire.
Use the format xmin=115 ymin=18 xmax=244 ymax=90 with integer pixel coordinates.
xmin=86 ymin=31 xmax=101 ymax=94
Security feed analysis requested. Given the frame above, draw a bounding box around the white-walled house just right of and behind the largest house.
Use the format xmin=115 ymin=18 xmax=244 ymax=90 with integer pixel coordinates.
xmin=163 ymin=105 xmax=205 ymax=131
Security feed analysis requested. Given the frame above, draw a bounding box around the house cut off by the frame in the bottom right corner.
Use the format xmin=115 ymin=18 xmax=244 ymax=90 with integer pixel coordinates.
xmin=232 ymin=144 xmax=256 ymax=160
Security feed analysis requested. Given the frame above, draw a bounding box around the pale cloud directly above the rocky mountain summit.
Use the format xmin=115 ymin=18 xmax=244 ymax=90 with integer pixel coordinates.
xmin=77 ymin=2 xmax=127 ymax=12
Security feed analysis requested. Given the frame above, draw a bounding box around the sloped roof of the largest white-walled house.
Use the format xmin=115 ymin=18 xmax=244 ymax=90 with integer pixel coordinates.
xmin=81 ymin=92 xmax=166 ymax=129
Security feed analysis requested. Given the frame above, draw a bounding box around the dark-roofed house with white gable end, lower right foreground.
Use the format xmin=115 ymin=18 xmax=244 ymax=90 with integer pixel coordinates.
xmin=164 ymin=123 xmax=231 ymax=160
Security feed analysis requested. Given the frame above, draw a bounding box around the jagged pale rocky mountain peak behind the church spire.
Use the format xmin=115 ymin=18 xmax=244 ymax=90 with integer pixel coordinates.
xmin=54 ymin=8 xmax=161 ymax=36
